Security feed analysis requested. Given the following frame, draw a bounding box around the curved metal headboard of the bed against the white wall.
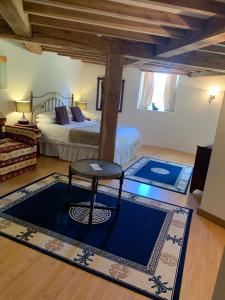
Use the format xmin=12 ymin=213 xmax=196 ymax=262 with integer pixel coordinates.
xmin=30 ymin=92 xmax=74 ymax=121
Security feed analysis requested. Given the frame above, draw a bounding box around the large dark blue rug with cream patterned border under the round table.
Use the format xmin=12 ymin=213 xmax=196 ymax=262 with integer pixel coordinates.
xmin=0 ymin=174 xmax=192 ymax=300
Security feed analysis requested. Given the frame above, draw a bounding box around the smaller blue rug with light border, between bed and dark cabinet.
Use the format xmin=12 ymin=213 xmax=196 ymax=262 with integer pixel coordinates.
xmin=125 ymin=156 xmax=193 ymax=194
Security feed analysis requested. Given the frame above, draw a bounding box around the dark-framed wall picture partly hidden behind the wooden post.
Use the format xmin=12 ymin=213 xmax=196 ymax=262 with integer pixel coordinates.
xmin=96 ymin=77 xmax=125 ymax=112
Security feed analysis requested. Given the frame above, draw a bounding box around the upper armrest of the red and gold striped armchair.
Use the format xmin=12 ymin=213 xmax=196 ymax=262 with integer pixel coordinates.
xmin=5 ymin=125 xmax=41 ymax=146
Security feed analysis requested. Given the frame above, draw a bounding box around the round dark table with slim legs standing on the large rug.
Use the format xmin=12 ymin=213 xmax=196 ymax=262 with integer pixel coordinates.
xmin=68 ymin=159 xmax=124 ymax=225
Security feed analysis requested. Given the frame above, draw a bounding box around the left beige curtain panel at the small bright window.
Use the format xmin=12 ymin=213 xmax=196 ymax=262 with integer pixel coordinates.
xmin=138 ymin=72 xmax=154 ymax=109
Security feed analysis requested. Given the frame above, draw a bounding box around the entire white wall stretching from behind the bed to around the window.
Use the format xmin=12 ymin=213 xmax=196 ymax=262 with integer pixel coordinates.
xmin=0 ymin=40 xmax=225 ymax=153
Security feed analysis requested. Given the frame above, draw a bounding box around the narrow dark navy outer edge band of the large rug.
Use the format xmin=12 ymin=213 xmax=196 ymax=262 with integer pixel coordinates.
xmin=0 ymin=172 xmax=193 ymax=300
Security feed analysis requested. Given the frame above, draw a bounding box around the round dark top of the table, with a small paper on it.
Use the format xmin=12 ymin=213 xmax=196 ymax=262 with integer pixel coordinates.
xmin=71 ymin=159 xmax=123 ymax=179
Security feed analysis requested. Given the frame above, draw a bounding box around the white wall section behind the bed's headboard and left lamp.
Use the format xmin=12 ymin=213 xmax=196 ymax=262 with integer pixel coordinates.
xmin=0 ymin=40 xmax=82 ymax=123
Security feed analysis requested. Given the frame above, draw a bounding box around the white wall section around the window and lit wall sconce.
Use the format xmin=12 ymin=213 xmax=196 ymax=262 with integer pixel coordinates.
xmin=81 ymin=64 xmax=225 ymax=153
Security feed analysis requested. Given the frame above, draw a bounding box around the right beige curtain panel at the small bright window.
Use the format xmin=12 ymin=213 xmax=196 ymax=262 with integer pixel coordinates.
xmin=163 ymin=74 xmax=177 ymax=111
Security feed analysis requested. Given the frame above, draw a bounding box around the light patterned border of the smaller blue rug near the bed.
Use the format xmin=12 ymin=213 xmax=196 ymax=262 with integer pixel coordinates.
xmin=124 ymin=156 xmax=193 ymax=196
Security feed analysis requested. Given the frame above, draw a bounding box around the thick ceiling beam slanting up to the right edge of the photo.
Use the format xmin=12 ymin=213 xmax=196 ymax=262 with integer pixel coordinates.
xmin=156 ymin=17 xmax=225 ymax=57
